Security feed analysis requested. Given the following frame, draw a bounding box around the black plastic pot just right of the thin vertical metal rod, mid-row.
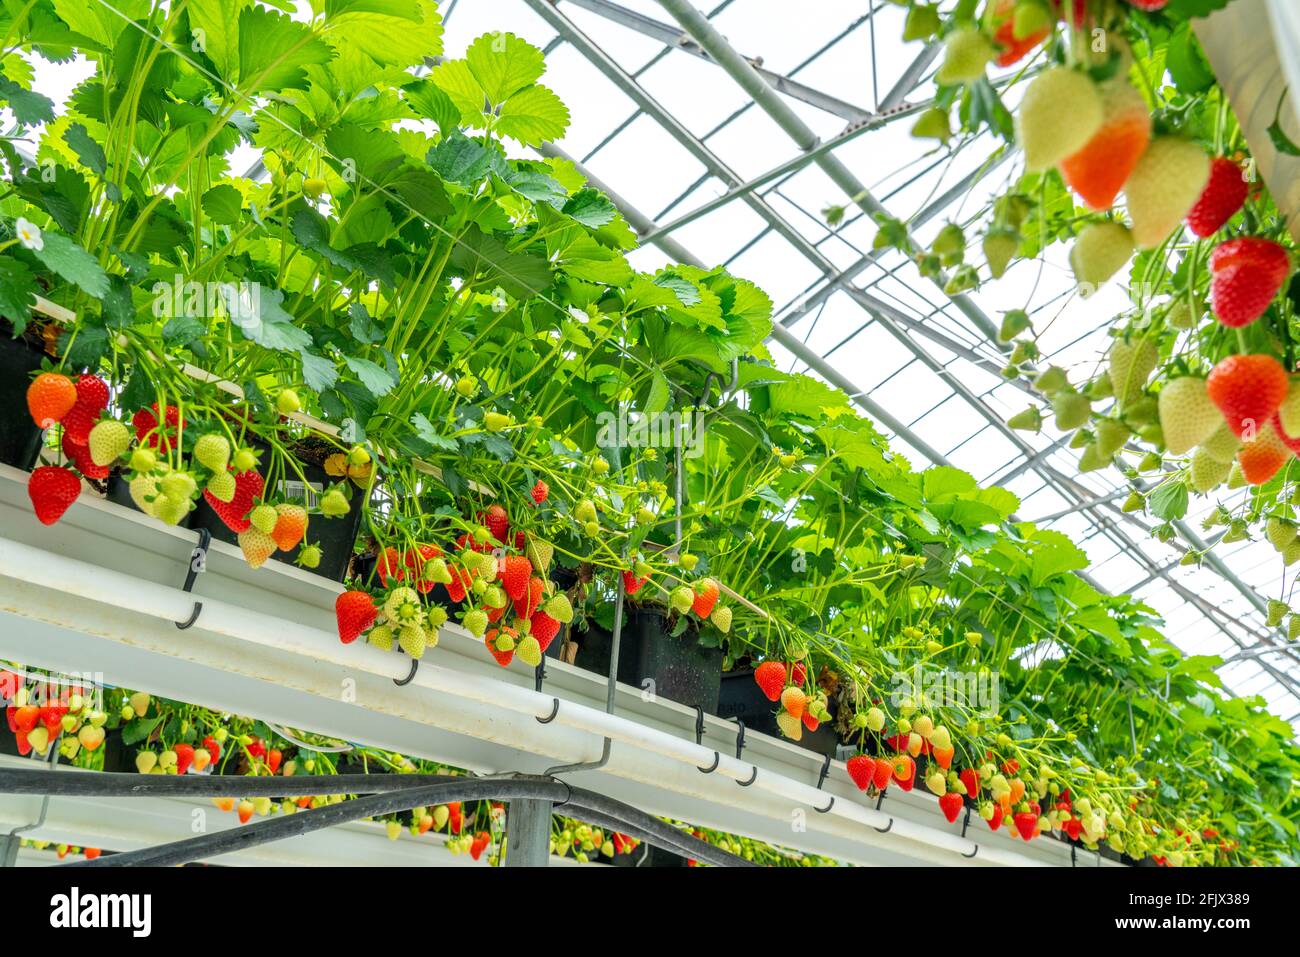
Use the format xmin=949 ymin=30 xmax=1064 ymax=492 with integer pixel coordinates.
xmin=574 ymin=607 xmax=723 ymax=713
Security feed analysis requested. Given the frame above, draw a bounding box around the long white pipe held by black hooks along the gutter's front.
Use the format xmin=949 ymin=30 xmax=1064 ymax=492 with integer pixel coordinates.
xmin=0 ymin=538 xmax=1043 ymax=866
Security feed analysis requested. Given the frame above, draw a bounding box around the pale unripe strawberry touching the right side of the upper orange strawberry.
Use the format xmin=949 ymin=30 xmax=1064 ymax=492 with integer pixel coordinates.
xmin=1125 ymin=137 xmax=1210 ymax=250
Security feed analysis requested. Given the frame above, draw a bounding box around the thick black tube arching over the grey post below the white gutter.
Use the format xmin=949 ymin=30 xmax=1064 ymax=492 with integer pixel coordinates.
xmin=38 ymin=771 xmax=754 ymax=867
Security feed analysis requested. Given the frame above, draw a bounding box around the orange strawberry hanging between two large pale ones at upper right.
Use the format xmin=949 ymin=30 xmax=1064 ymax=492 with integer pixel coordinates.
xmin=1060 ymin=77 xmax=1151 ymax=209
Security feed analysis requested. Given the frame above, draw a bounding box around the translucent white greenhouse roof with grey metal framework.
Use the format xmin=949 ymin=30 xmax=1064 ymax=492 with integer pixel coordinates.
xmin=426 ymin=0 xmax=1300 ymax=727
